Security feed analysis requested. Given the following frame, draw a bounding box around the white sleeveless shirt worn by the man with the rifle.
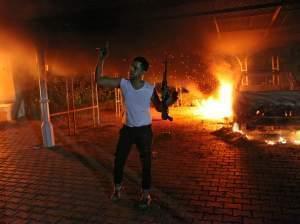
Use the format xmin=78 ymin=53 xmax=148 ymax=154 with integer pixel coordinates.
xmin=120 ymin=79 xmax=154 ymax=127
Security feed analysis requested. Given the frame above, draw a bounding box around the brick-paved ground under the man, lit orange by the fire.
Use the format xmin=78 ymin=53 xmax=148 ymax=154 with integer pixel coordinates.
xmin=0 ymin=107 xmax=300 ymax=224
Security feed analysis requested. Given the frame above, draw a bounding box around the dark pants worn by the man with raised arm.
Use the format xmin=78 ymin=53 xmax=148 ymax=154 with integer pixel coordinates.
xmin=114 ymin=125 xmax=153 ymax=190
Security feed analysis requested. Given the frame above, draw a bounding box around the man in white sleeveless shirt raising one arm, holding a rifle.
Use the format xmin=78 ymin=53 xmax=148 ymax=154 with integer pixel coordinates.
xmin=95 ymin=49 xmax=177 ymax=209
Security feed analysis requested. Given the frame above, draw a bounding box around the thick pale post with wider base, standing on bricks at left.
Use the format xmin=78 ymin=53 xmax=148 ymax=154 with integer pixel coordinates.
xmin=37 ymin=47 xmax=55 ymax=147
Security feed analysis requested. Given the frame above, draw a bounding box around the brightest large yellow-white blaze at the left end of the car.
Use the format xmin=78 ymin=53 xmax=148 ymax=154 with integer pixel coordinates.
xmin=194 ymin=81 xmax=233 ymax=120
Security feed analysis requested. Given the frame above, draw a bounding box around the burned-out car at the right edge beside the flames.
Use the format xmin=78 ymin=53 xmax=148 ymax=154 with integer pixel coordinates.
xmin=233 ymin=73 xmax=300 ymax=130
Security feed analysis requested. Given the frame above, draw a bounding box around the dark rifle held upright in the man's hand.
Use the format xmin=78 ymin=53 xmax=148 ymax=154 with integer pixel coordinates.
xmin=161 ymin=58 xmax=173 ymax=121
